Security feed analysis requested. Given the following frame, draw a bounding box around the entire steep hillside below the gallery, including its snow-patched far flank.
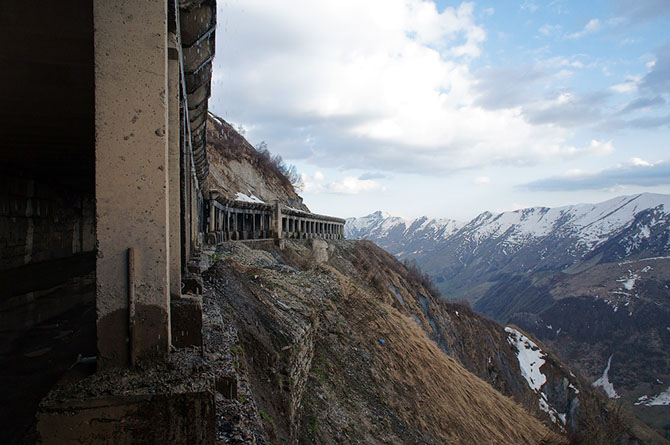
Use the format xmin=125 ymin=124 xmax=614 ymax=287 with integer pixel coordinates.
xmin=205 ymin=240 xmax=660 ymax=444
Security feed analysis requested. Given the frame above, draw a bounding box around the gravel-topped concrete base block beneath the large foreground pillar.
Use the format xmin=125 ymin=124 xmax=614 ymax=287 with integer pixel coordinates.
xmin=36 ymin=348 xmax=216 ymax=444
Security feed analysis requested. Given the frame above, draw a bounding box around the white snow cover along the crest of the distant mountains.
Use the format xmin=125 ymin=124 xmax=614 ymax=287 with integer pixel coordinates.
xmin=345 ymin=193 xmax=670 ymax=257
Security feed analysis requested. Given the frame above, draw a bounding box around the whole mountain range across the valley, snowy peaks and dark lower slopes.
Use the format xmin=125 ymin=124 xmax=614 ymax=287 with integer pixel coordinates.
xmin=345 ymin=193 xmax=670 ymax=436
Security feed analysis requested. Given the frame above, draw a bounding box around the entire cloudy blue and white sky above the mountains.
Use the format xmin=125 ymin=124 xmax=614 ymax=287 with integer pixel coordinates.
xmin=210 ymin=0 xmax=670 ymax=220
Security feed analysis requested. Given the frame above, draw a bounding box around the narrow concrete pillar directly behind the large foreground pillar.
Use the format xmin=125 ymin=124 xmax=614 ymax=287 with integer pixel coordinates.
xmin=167 ymin=27 xmax=182 ymax=297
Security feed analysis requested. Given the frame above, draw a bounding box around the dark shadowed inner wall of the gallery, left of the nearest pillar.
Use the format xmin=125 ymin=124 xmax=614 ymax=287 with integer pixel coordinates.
xmin=0 ymin=175 xmax=95 ymax=443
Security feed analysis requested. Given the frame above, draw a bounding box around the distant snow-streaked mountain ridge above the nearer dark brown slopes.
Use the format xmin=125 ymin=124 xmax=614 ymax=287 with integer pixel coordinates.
xmin=345 ymin=193 xmax=670 ymax=282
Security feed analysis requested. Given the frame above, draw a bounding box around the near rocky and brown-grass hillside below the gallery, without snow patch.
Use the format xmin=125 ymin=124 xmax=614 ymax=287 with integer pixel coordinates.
xmin=205 ymin=242 xmax=558 ymax=444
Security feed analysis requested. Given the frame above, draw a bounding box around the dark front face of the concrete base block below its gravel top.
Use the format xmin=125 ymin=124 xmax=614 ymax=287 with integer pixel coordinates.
xmin=37 ymin=391 xmax=216 ymax=445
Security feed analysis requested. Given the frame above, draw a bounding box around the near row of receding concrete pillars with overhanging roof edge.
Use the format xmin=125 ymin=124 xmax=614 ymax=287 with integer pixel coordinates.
xmin=93 ymin=0 xmax=215 ymax=369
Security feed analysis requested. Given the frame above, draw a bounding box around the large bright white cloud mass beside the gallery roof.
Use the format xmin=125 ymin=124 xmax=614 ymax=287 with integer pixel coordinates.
xmin=210 ymin=0 xmax=616 ymax=175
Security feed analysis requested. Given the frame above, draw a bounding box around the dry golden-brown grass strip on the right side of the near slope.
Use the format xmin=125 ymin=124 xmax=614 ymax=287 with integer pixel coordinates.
xmin=330 ymin=262 xmax=563 ymax=444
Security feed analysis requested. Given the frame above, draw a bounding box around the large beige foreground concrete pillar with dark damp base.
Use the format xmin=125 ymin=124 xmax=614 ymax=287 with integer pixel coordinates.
xmin=93 ymin=0 xmax=170 ymax=369
